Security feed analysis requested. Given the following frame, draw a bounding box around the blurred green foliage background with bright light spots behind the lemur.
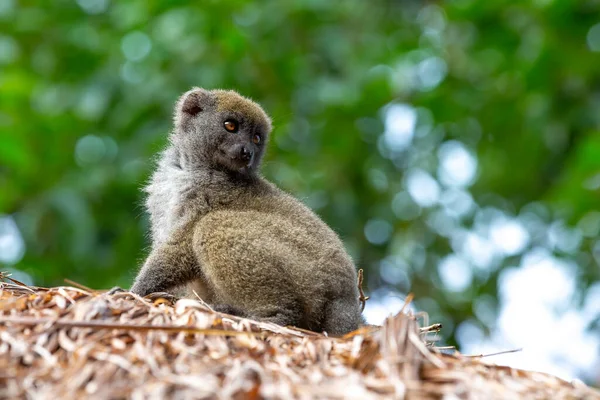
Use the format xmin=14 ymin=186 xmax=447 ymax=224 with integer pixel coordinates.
xmin=0 ymin=0 xmax=600 ymax=384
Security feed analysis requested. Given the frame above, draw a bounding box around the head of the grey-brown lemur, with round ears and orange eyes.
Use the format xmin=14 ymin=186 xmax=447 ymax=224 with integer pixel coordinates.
xmin=171 ymin=88 xmax=271 ymax=175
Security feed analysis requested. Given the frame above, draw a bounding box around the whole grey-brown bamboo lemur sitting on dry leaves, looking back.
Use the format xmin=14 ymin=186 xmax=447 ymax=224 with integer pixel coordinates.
xmin=131 ymin=88 xmax=362 ymax=335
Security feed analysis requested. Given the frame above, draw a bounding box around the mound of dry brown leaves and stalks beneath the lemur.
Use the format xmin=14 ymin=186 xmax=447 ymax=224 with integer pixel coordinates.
xmin=0 ymin=278 xmax=600 ymax=399
